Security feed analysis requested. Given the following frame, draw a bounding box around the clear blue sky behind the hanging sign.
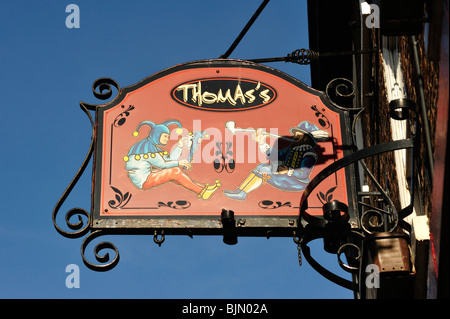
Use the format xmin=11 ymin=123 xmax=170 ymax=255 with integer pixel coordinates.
xmin=0 ymin=0 xmax=353 ymax=299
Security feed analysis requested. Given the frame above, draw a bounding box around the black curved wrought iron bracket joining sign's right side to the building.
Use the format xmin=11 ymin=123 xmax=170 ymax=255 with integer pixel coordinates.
xmin=294 ymin=79 xmax=419 ymax=292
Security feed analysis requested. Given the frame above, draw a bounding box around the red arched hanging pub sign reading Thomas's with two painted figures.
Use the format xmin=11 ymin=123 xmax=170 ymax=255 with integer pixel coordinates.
xmin=91 ymin=60 xmax=354 ymax=236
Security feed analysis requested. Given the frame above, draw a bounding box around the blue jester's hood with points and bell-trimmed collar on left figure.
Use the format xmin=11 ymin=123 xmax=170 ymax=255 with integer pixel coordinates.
xmin=124 ymin=120 xmax=181 ymax=161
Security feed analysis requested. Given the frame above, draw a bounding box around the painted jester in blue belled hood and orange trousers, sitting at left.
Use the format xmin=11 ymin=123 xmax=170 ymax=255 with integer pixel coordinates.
xmin=124 ymin=120 xmax=220 ymax=200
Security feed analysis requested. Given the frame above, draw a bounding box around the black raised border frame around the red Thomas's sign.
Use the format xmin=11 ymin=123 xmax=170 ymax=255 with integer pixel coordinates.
xmin=91 ymin=59 xmax=358 ymax=237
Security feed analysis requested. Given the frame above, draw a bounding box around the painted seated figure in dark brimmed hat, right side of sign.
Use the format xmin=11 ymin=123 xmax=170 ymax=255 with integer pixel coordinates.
xmin=224 ymin=121 xmax=328 ymax=200
